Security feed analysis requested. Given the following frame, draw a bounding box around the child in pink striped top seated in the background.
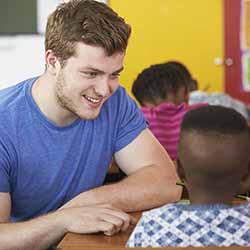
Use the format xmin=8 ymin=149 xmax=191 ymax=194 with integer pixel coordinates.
xmin=132 ymin=61 xmax=206 ymax=161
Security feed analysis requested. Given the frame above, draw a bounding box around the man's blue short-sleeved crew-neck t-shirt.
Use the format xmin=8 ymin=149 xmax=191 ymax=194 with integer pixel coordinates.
xmin=0 ymin=78 xmax=147 ymax=221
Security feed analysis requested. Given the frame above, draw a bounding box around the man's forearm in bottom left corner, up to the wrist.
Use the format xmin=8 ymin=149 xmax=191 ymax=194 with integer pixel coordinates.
xmin=0 ymin=213 xmax=66 ymax=250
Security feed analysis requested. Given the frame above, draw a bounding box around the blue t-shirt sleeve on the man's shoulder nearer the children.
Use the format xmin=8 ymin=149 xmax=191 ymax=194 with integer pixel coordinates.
xmin=114 ymin=88 xmax=147 ymax=152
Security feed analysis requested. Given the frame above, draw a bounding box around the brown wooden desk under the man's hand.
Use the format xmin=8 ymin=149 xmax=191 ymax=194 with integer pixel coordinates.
xmin=58 ymin=200 xmax=250 ymax=250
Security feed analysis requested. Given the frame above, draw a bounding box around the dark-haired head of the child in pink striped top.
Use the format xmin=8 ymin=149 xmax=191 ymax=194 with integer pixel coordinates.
xmin=132 ymin=62 xmax=190 ymax=107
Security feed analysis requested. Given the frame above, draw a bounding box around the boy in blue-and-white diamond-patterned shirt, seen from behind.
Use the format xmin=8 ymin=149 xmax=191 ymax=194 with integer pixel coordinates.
xmin=127 ymin=106 xmax=250 ymax=247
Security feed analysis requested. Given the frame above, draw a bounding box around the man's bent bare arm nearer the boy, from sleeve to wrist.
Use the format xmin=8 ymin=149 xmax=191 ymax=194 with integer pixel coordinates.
xmin=64 ymin=129 xmax=182 ymax=212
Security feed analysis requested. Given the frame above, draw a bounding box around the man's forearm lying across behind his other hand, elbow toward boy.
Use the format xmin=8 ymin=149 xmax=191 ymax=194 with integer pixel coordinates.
xmin=64 ymin=166 xmax=182 ymax=212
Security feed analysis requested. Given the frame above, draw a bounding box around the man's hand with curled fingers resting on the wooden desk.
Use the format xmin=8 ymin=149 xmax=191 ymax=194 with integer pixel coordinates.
xmin=60 ymin=205 xmax=136 ymax=236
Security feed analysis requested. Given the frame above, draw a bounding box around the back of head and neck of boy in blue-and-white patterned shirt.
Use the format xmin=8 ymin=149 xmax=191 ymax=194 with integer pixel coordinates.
xmin=177 ymin=106 xmax=250 ymax=204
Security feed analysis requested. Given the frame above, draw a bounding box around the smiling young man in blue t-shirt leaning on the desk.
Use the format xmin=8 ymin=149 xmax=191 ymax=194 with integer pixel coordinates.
xmin=0 ymin=0 xmax=181 ymax=250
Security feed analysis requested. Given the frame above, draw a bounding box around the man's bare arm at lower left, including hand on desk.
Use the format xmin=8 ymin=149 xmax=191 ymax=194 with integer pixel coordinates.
xmin=0 ymin=193 xmax=134 ymax=250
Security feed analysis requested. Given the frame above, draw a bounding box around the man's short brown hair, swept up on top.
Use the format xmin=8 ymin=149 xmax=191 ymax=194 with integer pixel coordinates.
xmin=45 ymin=0 xmax=131 ymax=61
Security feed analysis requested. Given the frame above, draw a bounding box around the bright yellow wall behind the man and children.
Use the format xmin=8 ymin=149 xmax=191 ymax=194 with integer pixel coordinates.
xmin=109 ymin=0 xmax=224 ymax=95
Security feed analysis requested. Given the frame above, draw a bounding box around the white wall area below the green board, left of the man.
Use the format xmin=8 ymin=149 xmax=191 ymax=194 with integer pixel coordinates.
xmin=0 ymin=35 xmax=45 ymax=88
